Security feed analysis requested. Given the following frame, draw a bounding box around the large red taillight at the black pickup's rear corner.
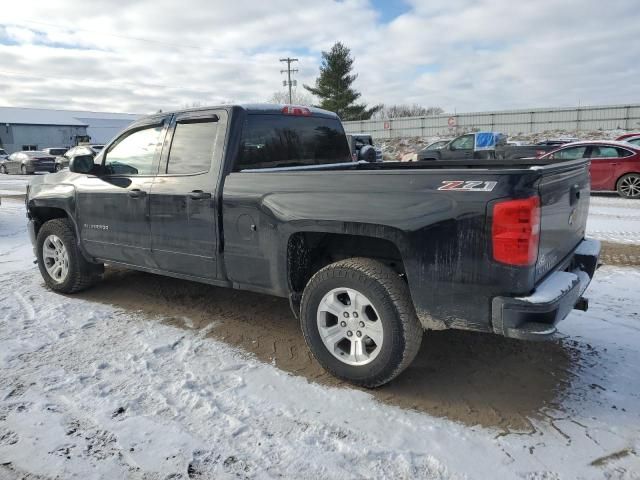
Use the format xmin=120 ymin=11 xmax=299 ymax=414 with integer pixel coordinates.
xmin=491 ymin=196 xmax=540 ymax=266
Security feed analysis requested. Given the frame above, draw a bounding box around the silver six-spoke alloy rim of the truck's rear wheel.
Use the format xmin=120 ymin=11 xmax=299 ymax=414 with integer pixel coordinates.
xmin=317 ymin=288 xmax=384 ymax=366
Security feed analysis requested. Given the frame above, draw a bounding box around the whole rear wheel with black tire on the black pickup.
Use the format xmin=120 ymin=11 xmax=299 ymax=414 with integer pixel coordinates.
xmin=300 ymin=258 xmax=423 ymax=388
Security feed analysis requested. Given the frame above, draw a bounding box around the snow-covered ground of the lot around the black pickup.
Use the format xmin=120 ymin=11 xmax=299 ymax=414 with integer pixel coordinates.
xmin=0 ymin=187 xmax=640 ymax=479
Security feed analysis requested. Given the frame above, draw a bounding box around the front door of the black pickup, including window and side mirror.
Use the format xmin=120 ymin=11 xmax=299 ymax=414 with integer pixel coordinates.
xmin=76 ymin=118 xmax=166 ymax=267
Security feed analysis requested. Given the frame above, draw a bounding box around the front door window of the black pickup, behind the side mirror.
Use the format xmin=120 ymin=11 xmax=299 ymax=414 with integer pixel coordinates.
xmin=105 ymin=126 xmax=162 ymax=175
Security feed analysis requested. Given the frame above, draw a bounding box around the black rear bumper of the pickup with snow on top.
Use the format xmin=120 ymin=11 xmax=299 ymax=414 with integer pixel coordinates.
xmin=491 ymin=239 xmax=600 ymax=340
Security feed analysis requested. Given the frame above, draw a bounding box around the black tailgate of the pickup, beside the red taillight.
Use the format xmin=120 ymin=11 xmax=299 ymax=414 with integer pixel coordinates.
xmin=535 ymin=160 xmax=591 ymax=282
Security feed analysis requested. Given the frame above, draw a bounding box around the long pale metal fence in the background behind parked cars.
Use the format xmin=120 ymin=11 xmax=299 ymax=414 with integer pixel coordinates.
xmin=344 ymin=104 xmax=640 ymax=138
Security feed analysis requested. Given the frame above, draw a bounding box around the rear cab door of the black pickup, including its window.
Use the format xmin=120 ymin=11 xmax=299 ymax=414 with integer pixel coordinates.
xmin=150 ymin=110 xmax=227 ymax=279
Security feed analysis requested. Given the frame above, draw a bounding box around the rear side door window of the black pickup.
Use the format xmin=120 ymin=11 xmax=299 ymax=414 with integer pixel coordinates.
xmin=167 ymin=120 xmax=218 ymax=174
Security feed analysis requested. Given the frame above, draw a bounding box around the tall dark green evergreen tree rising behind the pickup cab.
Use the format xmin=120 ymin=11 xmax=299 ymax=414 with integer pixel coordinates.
xmin=304 ymin=42 xmax=382 ymax=120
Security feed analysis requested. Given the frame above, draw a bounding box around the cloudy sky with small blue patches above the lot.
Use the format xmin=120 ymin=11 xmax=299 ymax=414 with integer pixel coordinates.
xmin=0 ymin=0 xmax=640 ymax=113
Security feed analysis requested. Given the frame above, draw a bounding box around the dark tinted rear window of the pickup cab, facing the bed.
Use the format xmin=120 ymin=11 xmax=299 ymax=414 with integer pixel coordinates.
xmin=234 ymin=115 xmax=351 ymax=171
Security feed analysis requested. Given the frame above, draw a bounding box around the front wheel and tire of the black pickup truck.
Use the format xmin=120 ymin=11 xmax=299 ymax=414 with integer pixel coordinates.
xmin=36 ymin=218 xmax=103 ymax=293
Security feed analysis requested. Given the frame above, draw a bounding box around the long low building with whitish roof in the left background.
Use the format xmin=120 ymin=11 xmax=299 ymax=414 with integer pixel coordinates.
xmin=0 ymin=107 xmax=140 ymax=153
